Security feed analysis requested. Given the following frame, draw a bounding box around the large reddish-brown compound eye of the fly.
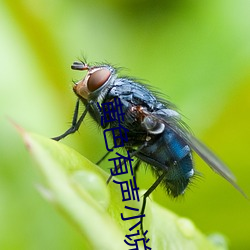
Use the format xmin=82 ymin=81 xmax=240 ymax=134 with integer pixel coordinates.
xmin=87 ymin=69 xmax=110 ymax=92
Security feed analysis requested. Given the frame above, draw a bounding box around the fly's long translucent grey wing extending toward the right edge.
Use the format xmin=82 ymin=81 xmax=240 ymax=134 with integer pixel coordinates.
xmin=149 ymin=111 xmax=248 ymax=198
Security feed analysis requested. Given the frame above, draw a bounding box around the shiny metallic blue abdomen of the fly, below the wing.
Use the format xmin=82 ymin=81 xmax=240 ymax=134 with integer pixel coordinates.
xmin=137 ymin=129 xmax=194 ymax=197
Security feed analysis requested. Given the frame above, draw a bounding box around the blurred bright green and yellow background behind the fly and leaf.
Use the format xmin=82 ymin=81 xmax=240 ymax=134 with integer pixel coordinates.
xmin=0 ymin=0 xmax=250 ymax=250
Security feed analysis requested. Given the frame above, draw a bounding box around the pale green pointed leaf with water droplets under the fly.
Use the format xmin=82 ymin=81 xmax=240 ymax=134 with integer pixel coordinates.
xmin=19 ymin=128 xmax=226 ymax=250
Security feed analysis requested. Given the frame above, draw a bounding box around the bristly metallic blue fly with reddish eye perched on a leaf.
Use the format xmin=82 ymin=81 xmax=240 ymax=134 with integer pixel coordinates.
xmin=53 ymin=62 xmax=246 ymax=232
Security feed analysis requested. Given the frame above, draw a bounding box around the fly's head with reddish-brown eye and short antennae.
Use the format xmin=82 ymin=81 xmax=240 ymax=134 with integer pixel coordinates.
xmin=71 ymin=62 xmax=116 ymax=100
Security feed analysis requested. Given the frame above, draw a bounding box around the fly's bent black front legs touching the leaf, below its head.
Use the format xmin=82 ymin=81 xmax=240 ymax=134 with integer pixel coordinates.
xmin=51 ymin=99 xmax=89 ymax=141
